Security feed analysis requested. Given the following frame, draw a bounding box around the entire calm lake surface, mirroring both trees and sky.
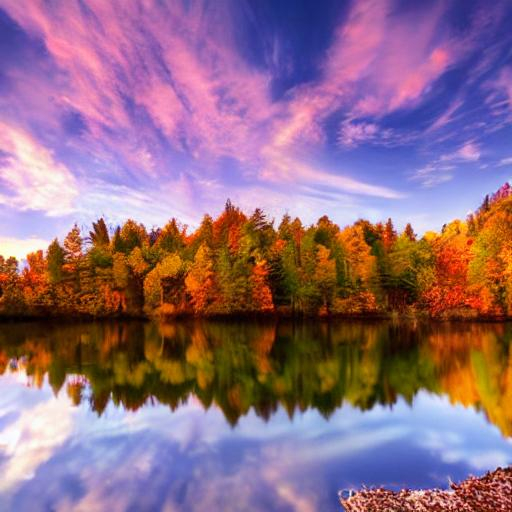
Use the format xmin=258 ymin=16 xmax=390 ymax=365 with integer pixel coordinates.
xmin=0 ymin=321 xmax=512 ymax=512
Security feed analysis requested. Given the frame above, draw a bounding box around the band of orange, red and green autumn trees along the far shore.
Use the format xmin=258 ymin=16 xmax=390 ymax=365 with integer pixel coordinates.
xmin=0 ymin=183 xmax=512 ymax=318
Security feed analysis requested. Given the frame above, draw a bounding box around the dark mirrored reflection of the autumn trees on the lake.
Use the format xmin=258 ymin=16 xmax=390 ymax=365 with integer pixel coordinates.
xmin=0 ymin=321 xmax=512 ymax=437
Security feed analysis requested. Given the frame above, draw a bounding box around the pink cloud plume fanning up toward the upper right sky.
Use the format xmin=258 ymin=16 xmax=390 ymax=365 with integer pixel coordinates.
xmin=274 ymin=0 xmax=464 ymax=151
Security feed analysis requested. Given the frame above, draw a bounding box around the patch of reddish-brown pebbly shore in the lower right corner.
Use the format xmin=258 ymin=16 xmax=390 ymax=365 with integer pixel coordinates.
xmin=340 ymin=466 xmax=512 ymax=512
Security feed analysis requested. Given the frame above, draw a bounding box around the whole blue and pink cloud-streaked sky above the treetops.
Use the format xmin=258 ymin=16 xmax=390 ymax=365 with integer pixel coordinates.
xmin=0 ymin=0 xmax=512 ymax=257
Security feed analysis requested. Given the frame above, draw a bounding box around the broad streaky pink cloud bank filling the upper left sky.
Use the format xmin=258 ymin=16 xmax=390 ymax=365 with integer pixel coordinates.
xmin=2 ymin=1 xmax=272 ymax=163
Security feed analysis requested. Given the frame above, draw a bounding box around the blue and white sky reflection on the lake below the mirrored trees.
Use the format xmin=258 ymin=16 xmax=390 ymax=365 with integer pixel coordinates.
xmin=0 ymin=371 xmax=512 ymax=512
